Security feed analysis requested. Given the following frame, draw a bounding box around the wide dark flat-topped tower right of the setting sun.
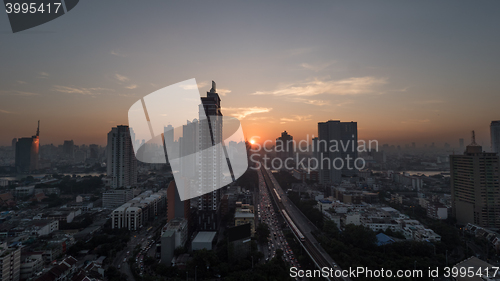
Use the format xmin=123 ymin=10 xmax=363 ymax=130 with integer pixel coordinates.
xmin=315 ymin=120 xmax=359 ymax=184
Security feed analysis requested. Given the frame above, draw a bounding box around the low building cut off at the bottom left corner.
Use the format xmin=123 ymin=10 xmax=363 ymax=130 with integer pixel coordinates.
xmin=0 ymin=242 xmax=21 ymax=281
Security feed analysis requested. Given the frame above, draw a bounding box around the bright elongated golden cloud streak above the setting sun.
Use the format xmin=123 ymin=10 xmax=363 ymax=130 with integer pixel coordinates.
xmin=252 ymin=76 xmax=387 ymax=97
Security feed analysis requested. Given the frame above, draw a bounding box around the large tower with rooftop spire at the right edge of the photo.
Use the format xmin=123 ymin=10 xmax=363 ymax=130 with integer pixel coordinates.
xmin=450 ymin=133 xmax=500 ymax=228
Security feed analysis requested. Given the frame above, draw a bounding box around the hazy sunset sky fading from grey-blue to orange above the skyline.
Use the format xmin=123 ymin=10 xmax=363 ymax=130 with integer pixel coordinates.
xmin=0 ymin=0 xmax=500 ymax=147
